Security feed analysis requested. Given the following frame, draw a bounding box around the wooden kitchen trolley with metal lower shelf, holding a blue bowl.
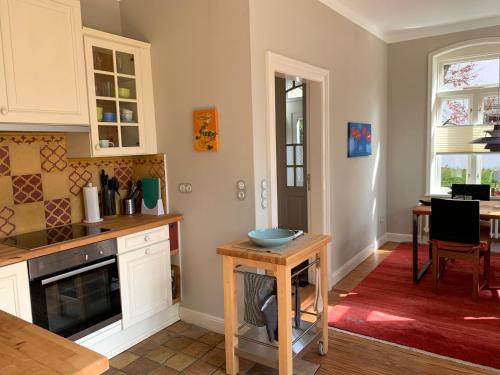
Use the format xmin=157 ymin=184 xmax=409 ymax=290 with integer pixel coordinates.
xmin=217 ymin=234 xmax=331 ymax=375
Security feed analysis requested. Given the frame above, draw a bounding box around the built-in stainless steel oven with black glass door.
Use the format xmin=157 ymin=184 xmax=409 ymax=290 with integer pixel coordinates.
xmin=28 ymin=239 xmax=121 ymax=340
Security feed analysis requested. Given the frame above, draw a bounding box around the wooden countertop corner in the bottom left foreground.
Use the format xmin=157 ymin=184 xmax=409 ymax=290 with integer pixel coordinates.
xmin=0 ymin=311 xmax=109 ymax=375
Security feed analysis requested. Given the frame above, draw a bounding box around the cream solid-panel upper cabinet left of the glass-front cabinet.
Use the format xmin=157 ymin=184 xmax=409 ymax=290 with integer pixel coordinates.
xmin=0 ymin=0 xmax=89 ymax=126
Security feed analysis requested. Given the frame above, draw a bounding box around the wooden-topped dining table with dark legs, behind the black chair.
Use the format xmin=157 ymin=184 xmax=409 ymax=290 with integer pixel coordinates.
xmin=412 ymin=197 xmax=500 ymax=283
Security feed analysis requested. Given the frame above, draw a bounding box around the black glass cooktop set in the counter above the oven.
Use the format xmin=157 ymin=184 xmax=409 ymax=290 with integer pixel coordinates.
xmin=1 ymin=224 xmax=109 ymax=250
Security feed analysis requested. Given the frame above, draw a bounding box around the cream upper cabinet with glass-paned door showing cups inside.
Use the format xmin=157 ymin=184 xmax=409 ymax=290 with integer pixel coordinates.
xmin=85 ymin=28 xmax=155 ymax=156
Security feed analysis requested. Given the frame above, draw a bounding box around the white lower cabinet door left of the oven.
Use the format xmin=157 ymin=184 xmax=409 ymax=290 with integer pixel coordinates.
xmin=0 ymin=262 xmax=32 ymax=323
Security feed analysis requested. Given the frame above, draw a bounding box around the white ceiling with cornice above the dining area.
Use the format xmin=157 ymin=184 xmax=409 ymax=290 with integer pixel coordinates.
xmin=319 ymin=0 xmax=500 ymax=43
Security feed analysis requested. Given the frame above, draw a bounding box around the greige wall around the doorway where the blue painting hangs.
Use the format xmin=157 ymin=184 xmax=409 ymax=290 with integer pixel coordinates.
xmin=250 ymin=0 xmax=387 ymax=272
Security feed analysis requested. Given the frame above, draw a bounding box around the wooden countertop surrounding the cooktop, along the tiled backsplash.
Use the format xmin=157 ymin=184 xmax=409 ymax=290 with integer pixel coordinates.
xmin=0 ymin=215 xmax=183 ymax=267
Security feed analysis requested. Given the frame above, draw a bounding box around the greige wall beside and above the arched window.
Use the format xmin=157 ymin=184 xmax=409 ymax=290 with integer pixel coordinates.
xmin=387 ymin=26 xmax=500 ymax=234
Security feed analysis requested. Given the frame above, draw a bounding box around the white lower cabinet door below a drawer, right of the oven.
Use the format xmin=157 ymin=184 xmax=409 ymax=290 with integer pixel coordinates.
xmin=118 ymin=241 xmax=172 ymax=329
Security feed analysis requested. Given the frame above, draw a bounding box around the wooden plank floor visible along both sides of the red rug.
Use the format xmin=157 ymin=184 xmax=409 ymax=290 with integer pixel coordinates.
xmin=304 ymin=242 xmax=500 ymax=375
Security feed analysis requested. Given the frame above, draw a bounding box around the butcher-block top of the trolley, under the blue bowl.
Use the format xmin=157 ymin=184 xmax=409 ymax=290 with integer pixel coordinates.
xmin=217 ymin=233 xmax=331 ymax=265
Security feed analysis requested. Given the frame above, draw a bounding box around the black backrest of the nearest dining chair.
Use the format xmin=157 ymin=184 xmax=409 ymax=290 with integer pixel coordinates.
xmin=431 ymin=198 xmax=480 ymax=244
